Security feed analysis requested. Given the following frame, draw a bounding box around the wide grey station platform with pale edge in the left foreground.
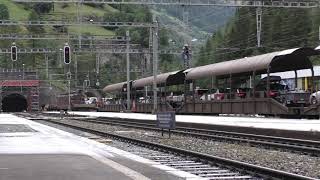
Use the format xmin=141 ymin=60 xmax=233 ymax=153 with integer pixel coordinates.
xmin=0 ymin=114 xmax=198 ymax=180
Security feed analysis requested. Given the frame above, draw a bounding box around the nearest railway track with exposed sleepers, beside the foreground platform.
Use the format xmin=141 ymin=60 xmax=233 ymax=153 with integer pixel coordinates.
xmin=25 ymin=118 xmax=312 ymax=180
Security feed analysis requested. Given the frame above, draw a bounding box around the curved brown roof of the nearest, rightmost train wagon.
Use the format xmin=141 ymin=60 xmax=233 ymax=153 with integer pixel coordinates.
xmin=186 ymin=48 xmax=320 ymax=80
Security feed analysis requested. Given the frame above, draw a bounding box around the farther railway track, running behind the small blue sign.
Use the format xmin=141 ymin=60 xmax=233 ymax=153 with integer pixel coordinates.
xmin=57 ymin=118 xmax=320 ymax=156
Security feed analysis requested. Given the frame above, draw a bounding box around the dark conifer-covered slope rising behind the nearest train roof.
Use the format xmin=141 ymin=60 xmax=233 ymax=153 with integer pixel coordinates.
xmin=197 ymin=8 xmax=320 ymax=87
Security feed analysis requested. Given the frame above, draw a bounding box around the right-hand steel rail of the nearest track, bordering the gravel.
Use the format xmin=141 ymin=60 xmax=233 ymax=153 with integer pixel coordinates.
xmin=38 ymin=120 xmax=314 ymax=180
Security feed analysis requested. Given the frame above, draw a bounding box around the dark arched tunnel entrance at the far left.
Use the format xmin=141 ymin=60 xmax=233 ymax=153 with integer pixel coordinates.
xmin=2 ymin=94 xmax=28 ymax=112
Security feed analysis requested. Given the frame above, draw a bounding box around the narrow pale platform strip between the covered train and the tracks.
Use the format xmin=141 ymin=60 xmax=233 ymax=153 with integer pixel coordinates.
xmin=52 ymin=111 xmax=320 ymax=132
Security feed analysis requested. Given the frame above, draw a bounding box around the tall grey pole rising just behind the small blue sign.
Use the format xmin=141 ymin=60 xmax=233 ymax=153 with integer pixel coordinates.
xmin=152 ymin=16 xmax=159 ymax=113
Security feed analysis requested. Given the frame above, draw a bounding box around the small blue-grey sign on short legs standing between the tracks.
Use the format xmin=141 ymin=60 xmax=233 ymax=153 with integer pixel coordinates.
xmin=157 ymin=111 xmax=176 ymax=138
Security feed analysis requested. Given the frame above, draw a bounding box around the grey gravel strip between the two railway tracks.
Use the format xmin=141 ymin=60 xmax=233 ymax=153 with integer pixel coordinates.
xmin=41 ymin=119 xmax=320 ymax=179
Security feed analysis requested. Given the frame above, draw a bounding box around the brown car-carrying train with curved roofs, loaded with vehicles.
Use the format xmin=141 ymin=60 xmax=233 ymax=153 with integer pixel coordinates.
xmin=99 ymin=47 xmax=320 ymax=118
